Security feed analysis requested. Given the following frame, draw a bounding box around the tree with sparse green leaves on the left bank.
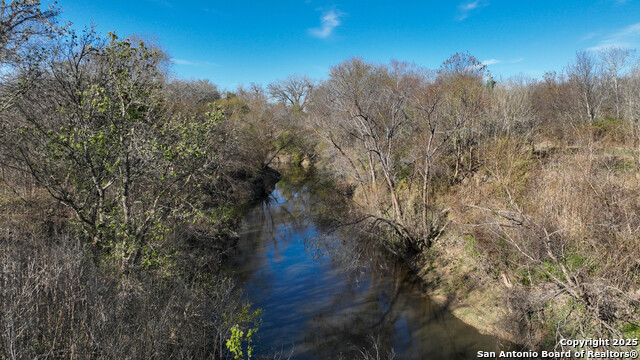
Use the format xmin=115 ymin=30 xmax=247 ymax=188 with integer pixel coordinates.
xmin=2 ymin=33 xmax=222 ymax=270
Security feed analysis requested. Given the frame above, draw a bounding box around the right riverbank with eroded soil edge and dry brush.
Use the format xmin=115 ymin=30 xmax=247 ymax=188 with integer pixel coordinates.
xmin=300 ymin=131 xmax=640 ymax=350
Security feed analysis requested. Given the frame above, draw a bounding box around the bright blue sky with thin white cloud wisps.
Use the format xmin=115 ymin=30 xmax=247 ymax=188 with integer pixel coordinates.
xmin=53 ymin=0 xmax=640 ymax=90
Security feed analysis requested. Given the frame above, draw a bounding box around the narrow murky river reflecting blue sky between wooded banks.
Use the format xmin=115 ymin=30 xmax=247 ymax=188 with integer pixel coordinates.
xmin=232 ymin=173 xmax=496 ymax=359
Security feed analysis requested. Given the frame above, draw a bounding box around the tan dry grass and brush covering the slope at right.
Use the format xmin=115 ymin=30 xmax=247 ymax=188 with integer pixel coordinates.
xmin=436 ymin=127 xmax=640 ymax=347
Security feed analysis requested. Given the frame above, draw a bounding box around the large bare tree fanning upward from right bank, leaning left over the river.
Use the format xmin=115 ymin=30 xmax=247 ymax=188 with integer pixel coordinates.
xmin=313 ymin=59 xmax=420 ymax=245
